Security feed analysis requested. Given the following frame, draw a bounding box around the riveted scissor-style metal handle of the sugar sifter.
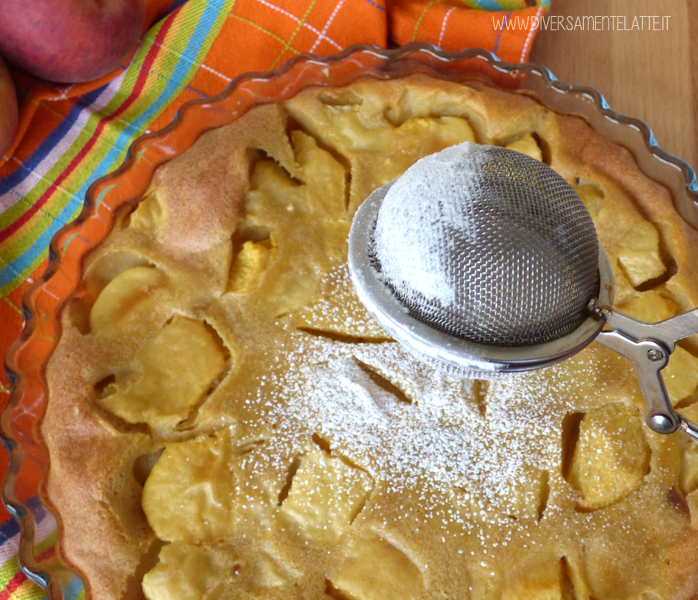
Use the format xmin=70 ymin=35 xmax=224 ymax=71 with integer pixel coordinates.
xmin=596 ymin=309 xmax=698 ymax=439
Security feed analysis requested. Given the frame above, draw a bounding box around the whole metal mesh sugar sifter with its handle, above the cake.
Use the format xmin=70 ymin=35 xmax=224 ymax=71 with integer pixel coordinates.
xmin=349 ymin=143 xmax=698 ymax=439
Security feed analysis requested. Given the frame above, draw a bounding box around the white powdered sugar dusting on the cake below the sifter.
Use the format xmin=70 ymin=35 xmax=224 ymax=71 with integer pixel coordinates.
xmin=253 ymin=332 xmax=588 ymax=519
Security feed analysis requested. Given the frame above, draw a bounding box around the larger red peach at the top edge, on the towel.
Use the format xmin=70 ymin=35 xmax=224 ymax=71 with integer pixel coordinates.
xmin=0 ymin=0 xmax=146 ymax=83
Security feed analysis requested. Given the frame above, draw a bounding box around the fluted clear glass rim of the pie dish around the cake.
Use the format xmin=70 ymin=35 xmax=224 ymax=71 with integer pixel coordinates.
xmin=2 ymin=43 xmax=698 ymax=600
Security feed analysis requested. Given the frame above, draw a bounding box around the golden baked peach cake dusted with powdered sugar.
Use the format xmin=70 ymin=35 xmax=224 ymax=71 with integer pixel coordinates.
xmin=41 ymin=76 xmax=698 ymax=600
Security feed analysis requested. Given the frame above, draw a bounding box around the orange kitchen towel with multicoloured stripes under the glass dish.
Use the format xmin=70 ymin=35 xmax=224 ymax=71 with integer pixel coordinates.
xmin=0 ymin=0 xmax=549 ymax=600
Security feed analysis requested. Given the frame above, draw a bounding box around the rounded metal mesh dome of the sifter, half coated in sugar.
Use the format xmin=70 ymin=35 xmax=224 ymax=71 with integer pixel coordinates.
xmin=372 ymin=143 xmax=599 ymax=346
